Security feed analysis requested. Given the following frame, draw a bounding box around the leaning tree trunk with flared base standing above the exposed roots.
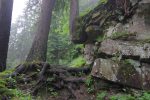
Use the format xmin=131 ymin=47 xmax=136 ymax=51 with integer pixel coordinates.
xmin=26 ymin=0 xmax=55 ymax=62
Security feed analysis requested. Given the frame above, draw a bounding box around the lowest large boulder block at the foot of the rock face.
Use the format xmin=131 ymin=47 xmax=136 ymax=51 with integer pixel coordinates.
xmin=92 ymin=58 xmax=150 ymax=90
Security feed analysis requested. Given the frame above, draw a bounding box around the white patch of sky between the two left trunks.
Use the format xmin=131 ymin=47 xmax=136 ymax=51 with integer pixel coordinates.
xmin=12 ymin=0 xmax=27 ymax=22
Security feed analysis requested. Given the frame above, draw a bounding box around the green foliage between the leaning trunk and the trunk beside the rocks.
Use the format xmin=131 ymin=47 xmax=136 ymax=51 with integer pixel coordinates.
xmin=47 ymin=0 xmax=83 ymax=65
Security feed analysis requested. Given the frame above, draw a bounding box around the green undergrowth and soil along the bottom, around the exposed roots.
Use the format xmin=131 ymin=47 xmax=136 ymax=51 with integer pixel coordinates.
xmin=0 ymin=65 xmax=150 ymax=100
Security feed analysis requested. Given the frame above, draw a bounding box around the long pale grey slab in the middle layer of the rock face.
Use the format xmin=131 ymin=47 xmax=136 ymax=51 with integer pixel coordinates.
xmin=98 ymin=39 xmax=150 ymax=62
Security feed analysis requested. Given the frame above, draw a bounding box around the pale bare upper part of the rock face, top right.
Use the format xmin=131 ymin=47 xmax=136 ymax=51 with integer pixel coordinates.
xmin=105 ymin=0 xmax=150 ymax=40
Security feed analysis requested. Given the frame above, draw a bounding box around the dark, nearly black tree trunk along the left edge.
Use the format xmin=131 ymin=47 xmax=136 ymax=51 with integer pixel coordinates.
xmin=0 ymin=0 xmax=13 ymax=72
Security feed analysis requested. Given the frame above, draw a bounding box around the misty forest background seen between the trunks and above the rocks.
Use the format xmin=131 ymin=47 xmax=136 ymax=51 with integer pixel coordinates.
xmin=7 ymin=0 xmax=100 ymax=67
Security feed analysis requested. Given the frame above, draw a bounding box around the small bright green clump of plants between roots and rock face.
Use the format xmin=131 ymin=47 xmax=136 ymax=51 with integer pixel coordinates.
xmin=70 ymin=56 xmax=86 ymax=67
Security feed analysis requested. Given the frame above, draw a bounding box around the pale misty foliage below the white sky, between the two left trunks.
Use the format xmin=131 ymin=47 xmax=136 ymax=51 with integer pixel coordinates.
xmin=7 ymin=0 xmax=41 ymax=68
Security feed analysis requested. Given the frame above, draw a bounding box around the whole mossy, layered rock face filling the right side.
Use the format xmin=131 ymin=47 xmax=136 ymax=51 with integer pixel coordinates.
xmin=74 ymin=0 xmax=150 ymax=90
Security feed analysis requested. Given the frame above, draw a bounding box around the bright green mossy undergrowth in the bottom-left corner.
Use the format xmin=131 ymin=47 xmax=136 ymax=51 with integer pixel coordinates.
xmin=0 ymin=70 xmax=32 ymax=100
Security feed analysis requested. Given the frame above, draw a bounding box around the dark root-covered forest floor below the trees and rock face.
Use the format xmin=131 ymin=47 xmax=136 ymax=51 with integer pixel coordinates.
xmin=0 ymin=63 xmax=150 ymax=100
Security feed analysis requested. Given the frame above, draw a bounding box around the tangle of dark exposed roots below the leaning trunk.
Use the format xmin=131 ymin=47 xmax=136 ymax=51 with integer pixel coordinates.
xmin=12 ymin=62 xmax=91 ymax=98
